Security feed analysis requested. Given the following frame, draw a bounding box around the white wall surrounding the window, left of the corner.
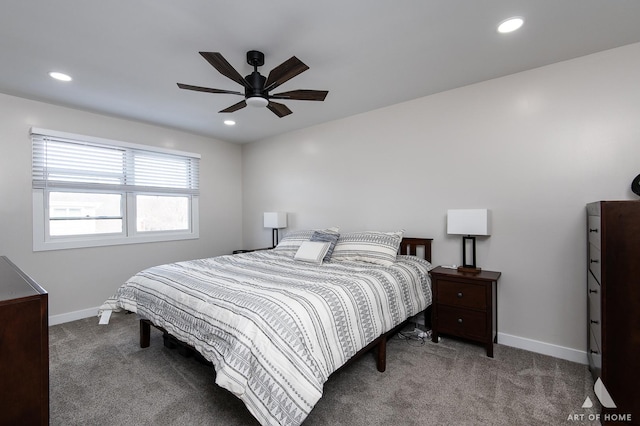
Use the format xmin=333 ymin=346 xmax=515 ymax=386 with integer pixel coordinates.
xmin=0 ymin=94 xmax=242 ymax=321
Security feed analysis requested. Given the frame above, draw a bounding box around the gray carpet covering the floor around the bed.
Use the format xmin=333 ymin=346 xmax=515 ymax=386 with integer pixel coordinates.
xmin=49 ymin=314 xmax=599 ymax=426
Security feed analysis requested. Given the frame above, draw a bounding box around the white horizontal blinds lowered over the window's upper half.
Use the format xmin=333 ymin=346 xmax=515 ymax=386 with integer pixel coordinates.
xmin=31 ymin=128 xmax=199 ymax=195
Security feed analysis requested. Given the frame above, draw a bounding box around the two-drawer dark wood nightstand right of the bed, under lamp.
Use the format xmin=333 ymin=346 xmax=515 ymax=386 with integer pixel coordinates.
xmin=430 ymin=266 xmax=501 ymax=358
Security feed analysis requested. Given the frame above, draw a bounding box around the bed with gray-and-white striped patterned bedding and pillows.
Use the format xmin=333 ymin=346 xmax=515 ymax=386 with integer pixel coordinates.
xmin=101 ymin=228 xmax=432 ymax=425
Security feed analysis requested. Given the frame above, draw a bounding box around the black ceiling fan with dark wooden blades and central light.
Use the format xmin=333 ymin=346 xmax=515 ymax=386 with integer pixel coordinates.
xmin=178 ymin=50 xmax=329 ymax=118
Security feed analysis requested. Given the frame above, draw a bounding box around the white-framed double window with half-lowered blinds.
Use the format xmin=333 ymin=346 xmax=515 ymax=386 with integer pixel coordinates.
xmin=31 ymin=128 xmax=200 ymax=251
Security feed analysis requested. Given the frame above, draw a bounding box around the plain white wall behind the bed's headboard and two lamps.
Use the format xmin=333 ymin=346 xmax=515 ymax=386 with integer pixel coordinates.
xmin=242 ymin=44 xmax=640 ymax=361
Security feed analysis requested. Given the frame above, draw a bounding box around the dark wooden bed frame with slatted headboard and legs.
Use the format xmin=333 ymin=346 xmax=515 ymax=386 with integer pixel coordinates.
xmin=140 ymin=237 xmax=433 ymax=373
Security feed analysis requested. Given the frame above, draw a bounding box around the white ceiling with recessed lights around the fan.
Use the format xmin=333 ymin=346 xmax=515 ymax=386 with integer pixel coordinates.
xmin=0 ymin=0 xmax=640 ymax=143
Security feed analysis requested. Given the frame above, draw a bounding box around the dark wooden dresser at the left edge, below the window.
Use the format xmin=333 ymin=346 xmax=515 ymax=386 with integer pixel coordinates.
xmin=0 ymin=256 xmax=49 ymax=426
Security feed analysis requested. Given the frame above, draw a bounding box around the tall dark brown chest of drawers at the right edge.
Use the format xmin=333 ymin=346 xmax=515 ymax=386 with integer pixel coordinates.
xmin=587 ymin=201 xmax=640 ymax=424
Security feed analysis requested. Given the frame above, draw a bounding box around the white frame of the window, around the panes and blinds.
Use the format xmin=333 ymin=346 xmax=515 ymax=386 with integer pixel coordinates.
xmin=31 ymin=128 xmax=200 ymax=251
